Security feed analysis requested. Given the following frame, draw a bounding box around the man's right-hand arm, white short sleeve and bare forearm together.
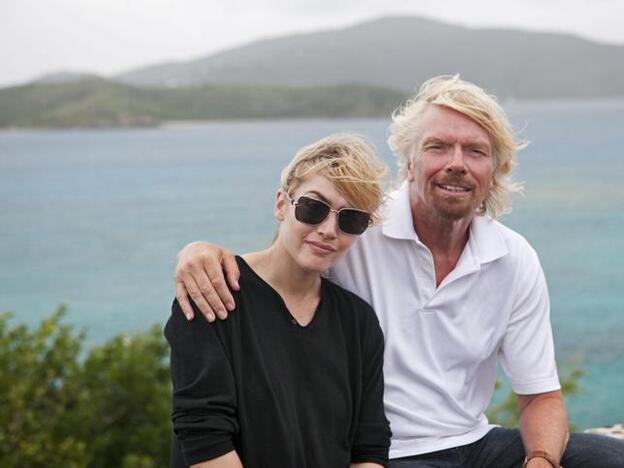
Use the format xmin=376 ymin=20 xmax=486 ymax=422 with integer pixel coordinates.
xmin=500 ymin=243 xmax=567 ymax=468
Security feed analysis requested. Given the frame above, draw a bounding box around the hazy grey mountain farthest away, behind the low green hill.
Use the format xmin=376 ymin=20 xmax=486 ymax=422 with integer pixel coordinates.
xmin=114 ymin=17 xmax=624 ymax=99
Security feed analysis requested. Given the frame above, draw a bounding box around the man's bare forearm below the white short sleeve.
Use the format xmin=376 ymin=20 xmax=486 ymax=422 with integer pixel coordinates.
xmin=517 ymin=390 xmax=568 ymax=468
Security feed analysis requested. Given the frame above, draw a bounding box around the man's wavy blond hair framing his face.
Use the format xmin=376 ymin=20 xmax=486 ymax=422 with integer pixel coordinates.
xmin=388 ymin=75 xmax=526 ymax=218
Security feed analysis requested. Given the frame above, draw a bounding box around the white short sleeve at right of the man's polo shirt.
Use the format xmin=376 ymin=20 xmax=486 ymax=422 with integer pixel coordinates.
xmin=500 ymin=244 xmax=560 ymax=395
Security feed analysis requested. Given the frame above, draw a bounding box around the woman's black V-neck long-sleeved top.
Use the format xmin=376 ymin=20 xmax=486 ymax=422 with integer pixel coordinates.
xmin=165 ymin=257 xmax=391 ymax=468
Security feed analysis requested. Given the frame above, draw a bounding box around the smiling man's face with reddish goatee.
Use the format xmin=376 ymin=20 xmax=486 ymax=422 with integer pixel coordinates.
xmin=407 ymin=105 xmax=494 ymax=221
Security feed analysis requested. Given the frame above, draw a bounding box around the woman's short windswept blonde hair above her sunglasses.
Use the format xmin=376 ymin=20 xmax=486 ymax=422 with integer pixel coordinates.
xmin=281 ymin=133 xmax=388 ymax=222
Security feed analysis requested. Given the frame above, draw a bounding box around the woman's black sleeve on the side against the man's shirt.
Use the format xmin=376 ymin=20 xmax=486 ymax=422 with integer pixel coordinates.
xmin=351 ymin=301 xmax=392 ymax=466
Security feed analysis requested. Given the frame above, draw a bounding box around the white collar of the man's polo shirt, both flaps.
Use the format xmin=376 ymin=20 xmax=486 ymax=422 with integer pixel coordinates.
xmin=381 ymin=181 xmax=509 ymax=264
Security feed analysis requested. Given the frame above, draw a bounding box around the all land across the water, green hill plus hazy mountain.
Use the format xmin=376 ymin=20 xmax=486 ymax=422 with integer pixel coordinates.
xmin=0 ymin=17 xmax=624 ymax=128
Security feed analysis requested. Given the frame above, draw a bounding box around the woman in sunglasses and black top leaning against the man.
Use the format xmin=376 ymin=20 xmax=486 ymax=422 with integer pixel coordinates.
xmin=165 ymin=135 xmax=390 ymax=468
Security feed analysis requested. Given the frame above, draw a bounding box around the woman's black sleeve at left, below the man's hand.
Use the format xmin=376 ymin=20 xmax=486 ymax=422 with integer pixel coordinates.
xmin=165 ymin=300 xmax=239 ymax=465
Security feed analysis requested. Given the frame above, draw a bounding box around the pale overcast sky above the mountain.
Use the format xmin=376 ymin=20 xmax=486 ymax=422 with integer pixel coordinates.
xmin=0 ymin=0 xmax=624 ymax=86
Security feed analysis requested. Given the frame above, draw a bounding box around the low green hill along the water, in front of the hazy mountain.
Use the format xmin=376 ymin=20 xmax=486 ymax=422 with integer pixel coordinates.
xmin=0 ymin=78 xmax=405 ymax=128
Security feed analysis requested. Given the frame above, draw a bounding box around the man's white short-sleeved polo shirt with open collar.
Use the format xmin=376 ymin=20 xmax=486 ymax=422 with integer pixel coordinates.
xmin=330 ymin=183 xmax=560 ymax=458
